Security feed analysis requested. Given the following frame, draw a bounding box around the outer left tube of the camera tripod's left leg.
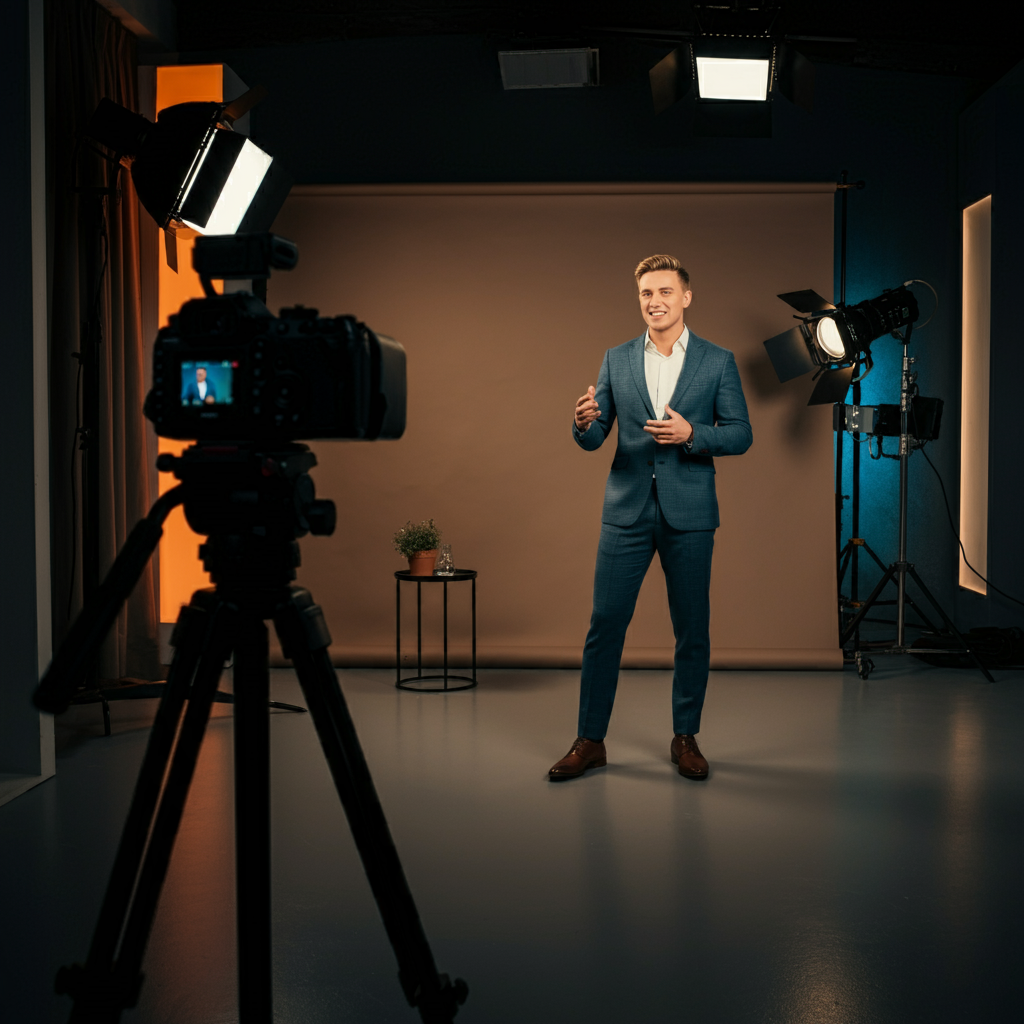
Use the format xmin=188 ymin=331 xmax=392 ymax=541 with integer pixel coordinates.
xmin=57 ymin=603 xmax=216 ymax=1020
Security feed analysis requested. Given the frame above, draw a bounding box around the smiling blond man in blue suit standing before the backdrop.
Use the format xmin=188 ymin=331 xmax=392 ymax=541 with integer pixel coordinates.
xmin=549 ymin=256 xmax=753 ymax=781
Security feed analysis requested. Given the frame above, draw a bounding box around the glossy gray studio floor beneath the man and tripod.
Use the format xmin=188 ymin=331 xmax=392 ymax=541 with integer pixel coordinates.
xmin=0 ymin=659 xmax=1024 ymax=1024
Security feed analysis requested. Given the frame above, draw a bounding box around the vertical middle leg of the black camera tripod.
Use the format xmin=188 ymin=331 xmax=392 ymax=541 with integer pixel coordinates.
xmin=234 ymin=617 xmax=273 ymax=1024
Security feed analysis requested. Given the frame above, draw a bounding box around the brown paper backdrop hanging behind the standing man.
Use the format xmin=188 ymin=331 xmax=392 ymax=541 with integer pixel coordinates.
xmin=269 ymin=184 xmax=842 ymax=668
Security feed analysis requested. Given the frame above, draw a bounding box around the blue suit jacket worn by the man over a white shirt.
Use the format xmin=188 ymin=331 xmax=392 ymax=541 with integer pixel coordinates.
xmin=572 ymin=331 xmax=754 ymax=529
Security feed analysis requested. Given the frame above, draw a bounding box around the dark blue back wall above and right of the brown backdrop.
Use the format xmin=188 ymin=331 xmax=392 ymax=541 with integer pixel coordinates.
xmin=182 ymin=37 xmax=1024 ymax=630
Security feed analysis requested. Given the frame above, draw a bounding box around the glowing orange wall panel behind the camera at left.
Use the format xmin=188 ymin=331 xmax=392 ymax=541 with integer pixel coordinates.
xmin=157 ymin=65 xmax=224 ymax=623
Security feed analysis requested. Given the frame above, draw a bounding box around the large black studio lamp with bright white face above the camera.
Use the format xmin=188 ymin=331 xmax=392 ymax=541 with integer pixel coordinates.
xmin=86 ymin=89 xmax=292 ymax=269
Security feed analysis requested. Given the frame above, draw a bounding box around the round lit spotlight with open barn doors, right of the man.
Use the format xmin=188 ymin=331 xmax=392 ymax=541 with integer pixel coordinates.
xmin=764 ymin=282 xmax=918 ymax=406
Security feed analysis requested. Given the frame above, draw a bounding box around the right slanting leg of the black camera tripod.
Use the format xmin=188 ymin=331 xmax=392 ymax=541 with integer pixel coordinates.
xmin=274 ymin=588 xmax=468 ymax=1024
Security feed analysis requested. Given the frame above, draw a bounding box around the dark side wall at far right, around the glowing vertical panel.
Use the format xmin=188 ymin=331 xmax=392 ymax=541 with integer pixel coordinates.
xmin=957 ymin=65 xmax=1024 ymax=625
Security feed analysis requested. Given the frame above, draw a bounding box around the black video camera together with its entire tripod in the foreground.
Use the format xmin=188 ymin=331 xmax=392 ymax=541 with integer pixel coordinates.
xmin=35 ymin=234 xmax=468 ymax=1024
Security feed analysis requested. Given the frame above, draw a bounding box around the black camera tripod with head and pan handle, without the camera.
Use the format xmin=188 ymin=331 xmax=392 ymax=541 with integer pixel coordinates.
xmin=35 ymin=443 xmax=468 ymax=1024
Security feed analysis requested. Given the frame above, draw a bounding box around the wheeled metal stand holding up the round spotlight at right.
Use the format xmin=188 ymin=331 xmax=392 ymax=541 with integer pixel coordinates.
xmin=840 ymin=324 xmax=995 ymax=683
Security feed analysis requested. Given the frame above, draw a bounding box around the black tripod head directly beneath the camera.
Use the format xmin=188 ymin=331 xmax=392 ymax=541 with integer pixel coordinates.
xmin=157 ymin=442 xmax=337 ymax=592
